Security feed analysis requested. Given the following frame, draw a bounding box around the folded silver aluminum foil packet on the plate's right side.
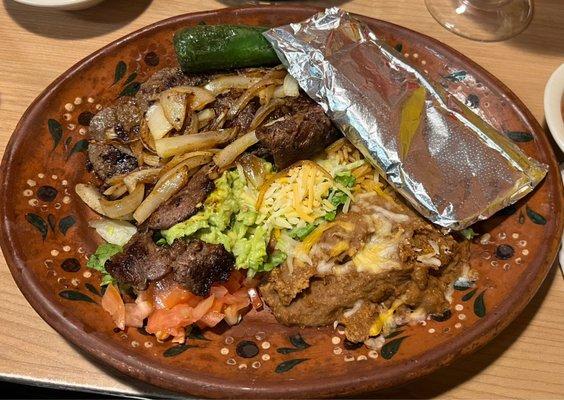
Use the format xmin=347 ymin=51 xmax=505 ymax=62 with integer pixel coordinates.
xmin=264 ymin=8 xmax=548 ymax=230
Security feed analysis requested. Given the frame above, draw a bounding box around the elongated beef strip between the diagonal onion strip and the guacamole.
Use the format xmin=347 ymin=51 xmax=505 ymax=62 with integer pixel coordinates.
xmin=148 ymin=164 xmax=215 ymax=229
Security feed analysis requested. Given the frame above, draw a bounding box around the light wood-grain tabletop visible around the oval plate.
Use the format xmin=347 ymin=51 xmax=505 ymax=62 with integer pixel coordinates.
xmin=0 ymin=0 xmax=564 ymax=398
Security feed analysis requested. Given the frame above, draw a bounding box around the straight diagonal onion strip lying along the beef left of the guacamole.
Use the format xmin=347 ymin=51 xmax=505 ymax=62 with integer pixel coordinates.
xmin=133 ymin=166 xmax=189 ymax=224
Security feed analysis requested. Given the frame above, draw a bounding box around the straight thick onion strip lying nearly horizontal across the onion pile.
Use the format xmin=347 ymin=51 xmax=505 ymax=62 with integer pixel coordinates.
xmin=155 ymin=128 xmax=237 ymax=158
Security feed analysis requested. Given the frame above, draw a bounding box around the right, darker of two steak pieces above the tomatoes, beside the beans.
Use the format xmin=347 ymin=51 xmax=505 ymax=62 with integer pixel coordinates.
xmin=172 ymin=240 xmax=235 ymax=296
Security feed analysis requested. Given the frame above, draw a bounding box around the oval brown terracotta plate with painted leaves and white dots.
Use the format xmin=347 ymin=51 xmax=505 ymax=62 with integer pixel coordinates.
xmin=0 ymin=6 xmax=563 ymax=397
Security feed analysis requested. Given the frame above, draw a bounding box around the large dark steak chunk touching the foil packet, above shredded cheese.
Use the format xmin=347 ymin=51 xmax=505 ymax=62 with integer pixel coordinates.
xmin=256 ymin=95 xmax=340 ymax=169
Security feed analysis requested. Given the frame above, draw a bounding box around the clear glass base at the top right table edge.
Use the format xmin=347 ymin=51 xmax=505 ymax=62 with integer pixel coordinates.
xmin=425 ymin=0 xmax=533 ymax=42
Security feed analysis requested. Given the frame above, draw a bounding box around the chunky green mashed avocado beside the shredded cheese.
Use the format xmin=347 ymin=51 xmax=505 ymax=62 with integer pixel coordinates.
xmin=162 ymin=166 xmax=286 ymax=276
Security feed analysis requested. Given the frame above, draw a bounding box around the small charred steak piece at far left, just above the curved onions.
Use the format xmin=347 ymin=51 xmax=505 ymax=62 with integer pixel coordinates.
xmin=88 ymin=143 xmax=138 ymax=180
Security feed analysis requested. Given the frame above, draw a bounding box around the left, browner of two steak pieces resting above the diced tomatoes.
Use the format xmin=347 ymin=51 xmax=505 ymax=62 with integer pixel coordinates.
xmin=106 ymin=230 xmax=186 ymax=290
